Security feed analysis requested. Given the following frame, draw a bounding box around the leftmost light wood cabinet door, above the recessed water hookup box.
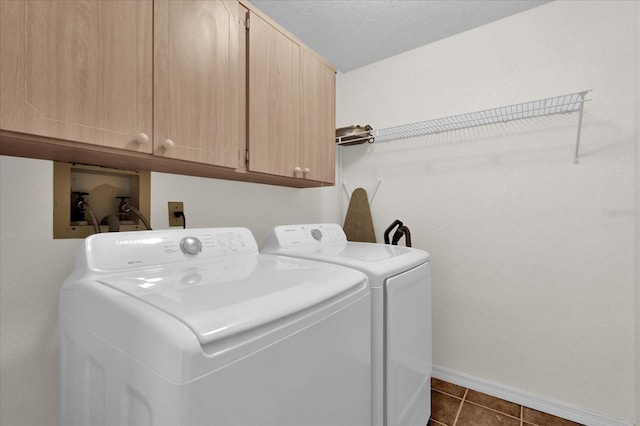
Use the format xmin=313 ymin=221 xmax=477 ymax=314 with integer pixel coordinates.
xmin=0 ymin=0 xmax=153 ymax=152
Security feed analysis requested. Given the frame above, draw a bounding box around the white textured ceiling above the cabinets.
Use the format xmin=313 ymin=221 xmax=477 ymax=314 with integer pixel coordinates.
xmin=251 ymin=0 xmax=548 ymax=72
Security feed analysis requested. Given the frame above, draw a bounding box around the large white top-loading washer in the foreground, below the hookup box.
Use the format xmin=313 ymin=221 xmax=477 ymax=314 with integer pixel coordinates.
xmin=59 ymin=228 xmax=371 ymax=426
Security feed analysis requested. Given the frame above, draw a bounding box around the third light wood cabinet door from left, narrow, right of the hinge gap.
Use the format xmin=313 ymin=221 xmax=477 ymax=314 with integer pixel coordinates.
xmin=248 ymin=12 xmax=302 ymax=177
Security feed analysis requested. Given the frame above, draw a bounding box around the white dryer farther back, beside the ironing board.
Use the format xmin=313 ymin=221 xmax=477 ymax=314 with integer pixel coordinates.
xmin=261 ymin=224 xmax=432 ymax=426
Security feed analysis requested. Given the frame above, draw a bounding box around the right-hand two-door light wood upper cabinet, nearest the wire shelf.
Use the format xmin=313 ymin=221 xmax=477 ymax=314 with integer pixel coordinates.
xmin=247 ymin=12 xmax=335 ymax=183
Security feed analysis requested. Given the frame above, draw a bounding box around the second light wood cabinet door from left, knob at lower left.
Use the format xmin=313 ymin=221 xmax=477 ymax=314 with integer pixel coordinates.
xmin=154 ymin=0 xmax=244 ymax=168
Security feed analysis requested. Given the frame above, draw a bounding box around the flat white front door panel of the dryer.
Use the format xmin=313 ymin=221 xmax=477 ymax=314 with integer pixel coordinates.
xmin=385 ymin=262 xmax=431 ymax=426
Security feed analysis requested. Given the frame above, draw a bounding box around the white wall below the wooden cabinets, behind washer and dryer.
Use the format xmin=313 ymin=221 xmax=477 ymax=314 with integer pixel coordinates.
xmin=0 ymin=156 xmax=338 ymax=426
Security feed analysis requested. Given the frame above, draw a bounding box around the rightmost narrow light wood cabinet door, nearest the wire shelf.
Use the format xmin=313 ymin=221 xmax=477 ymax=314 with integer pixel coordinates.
xmin=301 ymin=50 xmax=336 ymax=183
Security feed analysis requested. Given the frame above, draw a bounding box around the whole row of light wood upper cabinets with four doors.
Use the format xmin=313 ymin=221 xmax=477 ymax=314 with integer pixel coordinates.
xmin=0 ymin=0 xmax=335 ymax=187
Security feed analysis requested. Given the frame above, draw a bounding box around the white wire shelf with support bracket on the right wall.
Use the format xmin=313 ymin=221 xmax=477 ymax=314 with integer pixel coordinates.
xmin=336 ymin=90 xmax=590 ymax=163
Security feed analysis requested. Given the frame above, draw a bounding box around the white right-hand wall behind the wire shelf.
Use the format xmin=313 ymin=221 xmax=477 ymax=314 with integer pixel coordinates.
xmin=337 ymin=1 xmax=640 ymax=423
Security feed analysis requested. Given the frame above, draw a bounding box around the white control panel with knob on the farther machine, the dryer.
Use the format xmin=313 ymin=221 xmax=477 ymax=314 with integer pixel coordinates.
xmin=267 ymin=223 xmax=347 ymax=249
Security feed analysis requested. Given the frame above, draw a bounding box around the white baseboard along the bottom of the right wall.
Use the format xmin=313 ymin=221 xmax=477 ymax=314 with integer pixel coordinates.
xmin=432 ymin=365 xmax=634 ymax=426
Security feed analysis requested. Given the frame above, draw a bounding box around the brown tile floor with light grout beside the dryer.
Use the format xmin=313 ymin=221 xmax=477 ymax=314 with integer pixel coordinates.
xmin=429 ymin=379 xmax=580 ymax=426
